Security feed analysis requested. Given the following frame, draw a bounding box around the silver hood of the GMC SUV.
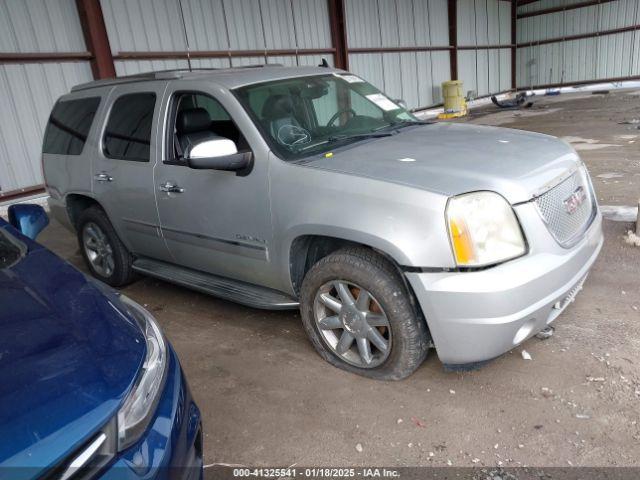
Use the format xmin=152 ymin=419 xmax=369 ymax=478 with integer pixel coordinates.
xmin=305 ymin=123 xmax=579 ymax=204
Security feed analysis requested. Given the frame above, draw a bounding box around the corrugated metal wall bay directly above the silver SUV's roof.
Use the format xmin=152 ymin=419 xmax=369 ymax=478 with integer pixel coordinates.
xmin=101 ymin=0 xmax=333 ymax=75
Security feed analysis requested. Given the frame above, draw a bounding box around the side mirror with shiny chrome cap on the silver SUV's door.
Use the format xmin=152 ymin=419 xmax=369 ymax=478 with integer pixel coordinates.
xmin=184 ymin=138 xmax=253 ymax=175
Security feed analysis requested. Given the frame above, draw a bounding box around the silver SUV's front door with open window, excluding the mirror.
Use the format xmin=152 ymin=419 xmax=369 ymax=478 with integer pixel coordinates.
xmin=155 ymin=82 xmax=272 ymax=286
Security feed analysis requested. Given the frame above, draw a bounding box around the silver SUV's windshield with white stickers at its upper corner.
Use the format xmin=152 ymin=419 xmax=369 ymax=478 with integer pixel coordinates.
xmin=235 ymin=73 xmax=419 ymax=160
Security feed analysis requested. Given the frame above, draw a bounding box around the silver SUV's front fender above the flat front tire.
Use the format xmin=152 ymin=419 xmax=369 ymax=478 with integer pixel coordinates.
xmin=270 ymin=157 xmax=455 ymax=290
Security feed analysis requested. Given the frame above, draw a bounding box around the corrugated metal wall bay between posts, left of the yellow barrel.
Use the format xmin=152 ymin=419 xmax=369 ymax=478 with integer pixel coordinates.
xmin=346 ymin=0 xmax=451 ymax=108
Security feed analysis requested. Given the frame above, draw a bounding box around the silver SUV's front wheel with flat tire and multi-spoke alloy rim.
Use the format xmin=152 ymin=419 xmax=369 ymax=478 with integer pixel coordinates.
xmin=300 ymin=247 xmax=429 ymax=380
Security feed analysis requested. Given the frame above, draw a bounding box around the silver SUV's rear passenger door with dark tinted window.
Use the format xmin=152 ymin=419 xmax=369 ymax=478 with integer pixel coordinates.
xmin=92 ymin=82 xmax=169 ymax=260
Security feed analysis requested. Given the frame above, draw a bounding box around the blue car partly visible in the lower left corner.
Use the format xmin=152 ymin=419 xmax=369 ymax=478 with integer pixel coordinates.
xmin=0 ymin=205 xmax=203 ymax=480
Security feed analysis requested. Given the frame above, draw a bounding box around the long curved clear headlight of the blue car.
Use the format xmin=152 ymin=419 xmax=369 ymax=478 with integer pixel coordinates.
xmin=118 ymin=295 xmax=167 ymax=451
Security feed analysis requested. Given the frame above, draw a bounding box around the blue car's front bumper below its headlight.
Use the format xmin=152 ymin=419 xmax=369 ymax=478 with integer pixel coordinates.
xmin=100 ymin=347 xmax=203 ymax=480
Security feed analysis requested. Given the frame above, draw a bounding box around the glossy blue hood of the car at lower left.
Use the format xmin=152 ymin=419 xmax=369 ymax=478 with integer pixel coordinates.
xmin=0 ymin=219 xmax=146 ymax=472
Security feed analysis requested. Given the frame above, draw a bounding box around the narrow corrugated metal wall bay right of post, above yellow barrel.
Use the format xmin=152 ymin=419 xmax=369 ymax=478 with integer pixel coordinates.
xmin=457 ymin=0 xmax=512 ymax=96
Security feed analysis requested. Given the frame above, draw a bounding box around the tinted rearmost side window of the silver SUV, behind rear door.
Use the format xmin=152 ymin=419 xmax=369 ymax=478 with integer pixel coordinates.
xmin=42 ymin=97 xmax=100 ymax=155
